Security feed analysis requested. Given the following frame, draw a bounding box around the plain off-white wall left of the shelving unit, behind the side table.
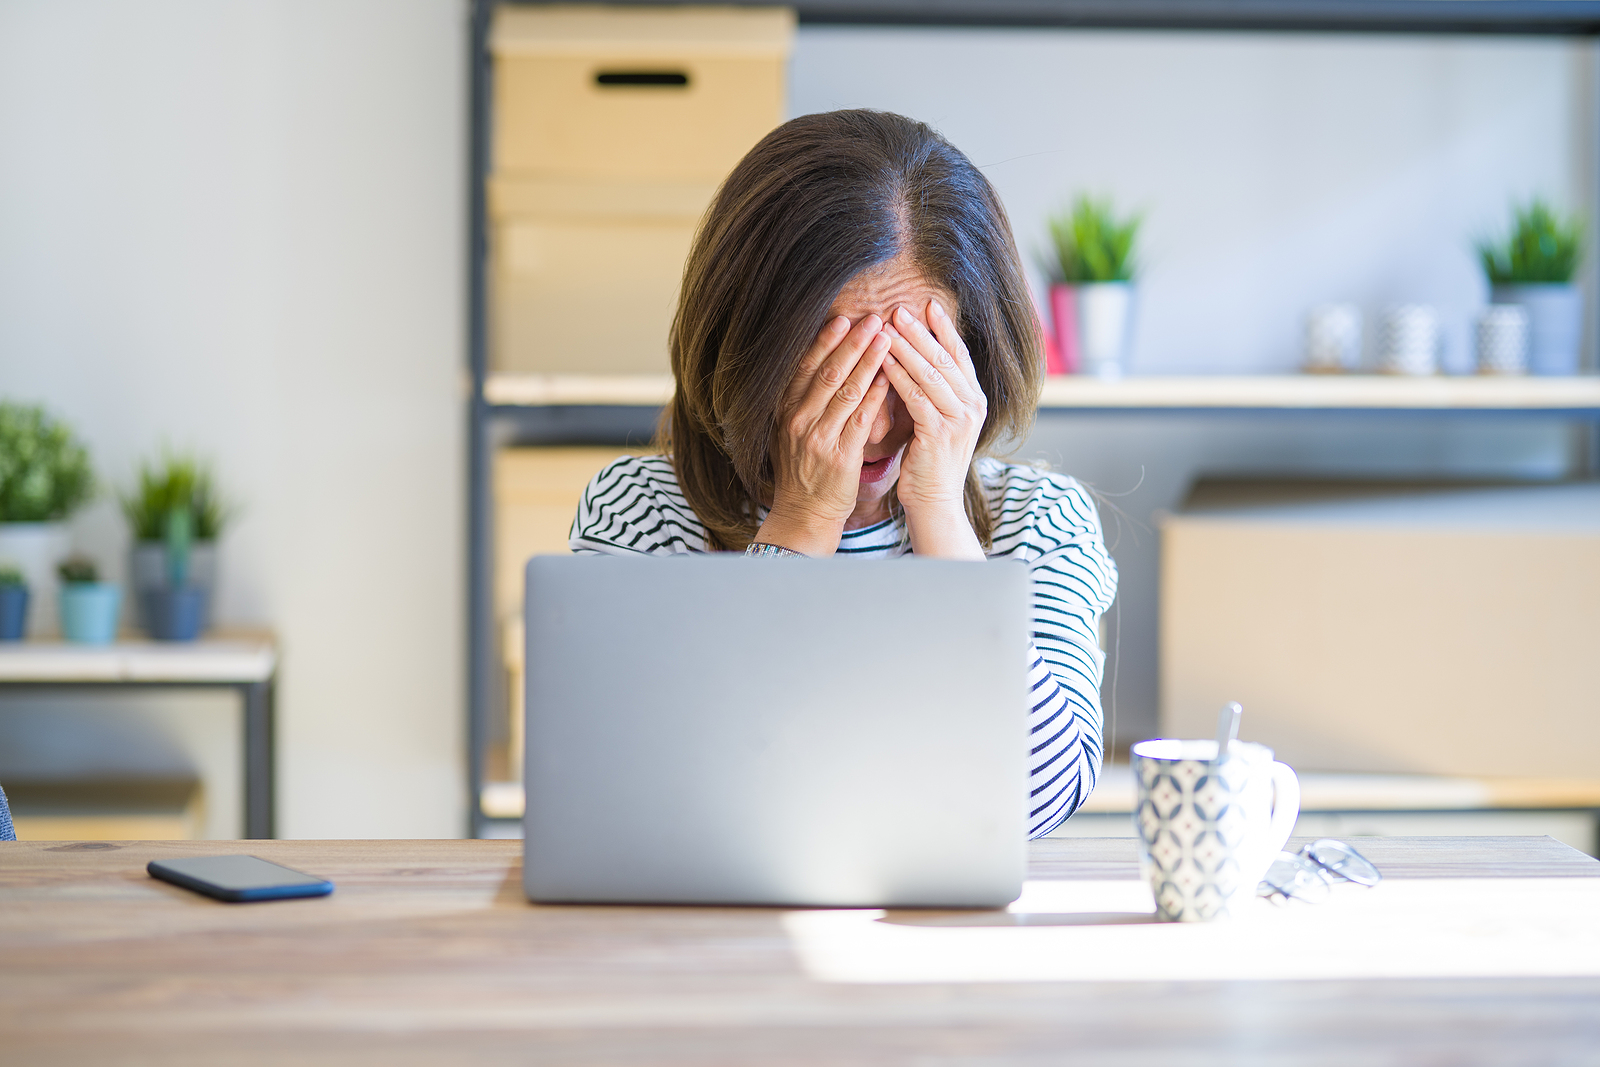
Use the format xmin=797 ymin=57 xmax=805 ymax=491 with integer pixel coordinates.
xmin=0 ymin=0 xmax=466 ymax=837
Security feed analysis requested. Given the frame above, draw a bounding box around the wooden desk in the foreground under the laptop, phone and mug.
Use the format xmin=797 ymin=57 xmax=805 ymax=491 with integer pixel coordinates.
xmin=0 ymin=838 xmax=1600 ymax=1067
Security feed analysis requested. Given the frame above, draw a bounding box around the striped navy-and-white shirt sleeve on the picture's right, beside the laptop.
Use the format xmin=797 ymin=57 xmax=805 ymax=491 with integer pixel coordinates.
xmin=992 ymin=467 xmax=1117 ymax=837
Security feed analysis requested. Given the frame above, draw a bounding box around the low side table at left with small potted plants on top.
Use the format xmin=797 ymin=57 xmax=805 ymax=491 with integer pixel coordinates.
xmin=0 ymin=633 xmax=278 ymax=838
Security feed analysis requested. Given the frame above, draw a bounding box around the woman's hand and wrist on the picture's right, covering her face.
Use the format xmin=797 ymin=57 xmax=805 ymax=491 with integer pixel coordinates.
xmin=883 ymin=301 xmax=989 ymax=560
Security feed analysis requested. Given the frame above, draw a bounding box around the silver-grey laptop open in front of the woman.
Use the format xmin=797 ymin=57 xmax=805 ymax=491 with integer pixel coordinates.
xmin=523 ymin=555 xmax=1029 ymax=907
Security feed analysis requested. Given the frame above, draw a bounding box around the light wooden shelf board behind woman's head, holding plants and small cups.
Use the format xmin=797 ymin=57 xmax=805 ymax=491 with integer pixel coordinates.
xmin=483 ymin=374 xmax=1600 ymax=414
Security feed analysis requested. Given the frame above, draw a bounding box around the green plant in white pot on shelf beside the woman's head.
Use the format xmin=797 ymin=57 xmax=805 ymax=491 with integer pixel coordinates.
xmin=1046 ymin=197 xmax=1144 ymax=378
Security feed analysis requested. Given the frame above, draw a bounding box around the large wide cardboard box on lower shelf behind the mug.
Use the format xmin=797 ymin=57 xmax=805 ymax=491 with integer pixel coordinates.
xmin=1160 ymin=483 xmax=1600 ymax=777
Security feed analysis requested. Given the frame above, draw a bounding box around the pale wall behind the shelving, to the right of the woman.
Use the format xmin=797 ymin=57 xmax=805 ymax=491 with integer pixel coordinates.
xmin=790 ymin=27 xmax=1600 ymax=744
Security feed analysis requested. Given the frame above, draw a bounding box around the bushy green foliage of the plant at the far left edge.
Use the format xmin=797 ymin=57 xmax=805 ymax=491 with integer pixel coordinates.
xmin=0 ymin=402 xmax=94 ymax=523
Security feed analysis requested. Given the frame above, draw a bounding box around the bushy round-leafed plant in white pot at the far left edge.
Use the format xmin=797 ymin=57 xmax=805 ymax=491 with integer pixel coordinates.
xmin=0 ymin=402 xmax=94 ymax=633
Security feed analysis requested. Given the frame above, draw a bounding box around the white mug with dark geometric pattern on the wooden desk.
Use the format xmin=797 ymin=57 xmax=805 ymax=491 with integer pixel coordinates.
xmin=1133 ymin=741 xmax=1299 ymax=923
